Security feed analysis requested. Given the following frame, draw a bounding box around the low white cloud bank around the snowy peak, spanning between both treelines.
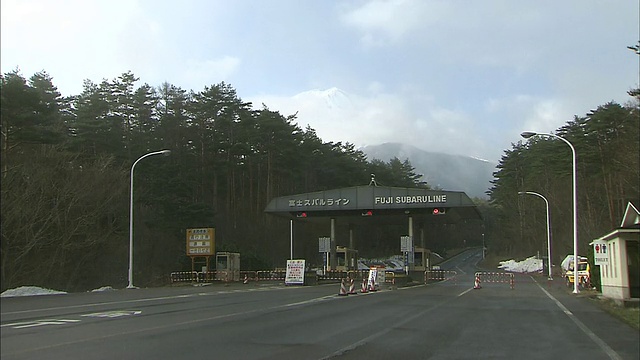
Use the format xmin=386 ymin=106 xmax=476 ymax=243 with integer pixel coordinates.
xmin=248 ymin=82 xmax=600 ymax=162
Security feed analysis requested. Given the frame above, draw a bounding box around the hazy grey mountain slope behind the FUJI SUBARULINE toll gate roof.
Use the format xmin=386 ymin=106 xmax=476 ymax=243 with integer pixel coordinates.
xmin=360 ymin=143 xmax=496 ymax=198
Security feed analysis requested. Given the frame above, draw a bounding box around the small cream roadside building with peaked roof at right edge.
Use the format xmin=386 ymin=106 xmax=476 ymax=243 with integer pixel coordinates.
xmin=590 ymin=203 xmax=640 ymax=302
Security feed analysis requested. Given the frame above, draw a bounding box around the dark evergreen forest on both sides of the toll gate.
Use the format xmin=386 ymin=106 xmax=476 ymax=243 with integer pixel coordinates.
xmin=0 ymin=70 xmax=640 ymax=291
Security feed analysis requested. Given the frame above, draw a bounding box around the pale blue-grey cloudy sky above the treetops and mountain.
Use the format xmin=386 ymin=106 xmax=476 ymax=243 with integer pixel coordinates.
xmin=0 ymin=0 xmax=640 ymax=162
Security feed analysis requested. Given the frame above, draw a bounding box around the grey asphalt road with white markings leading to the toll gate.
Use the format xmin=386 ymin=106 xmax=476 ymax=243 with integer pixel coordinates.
xmin=0 ymin=251 xmax=640 ymax=360
